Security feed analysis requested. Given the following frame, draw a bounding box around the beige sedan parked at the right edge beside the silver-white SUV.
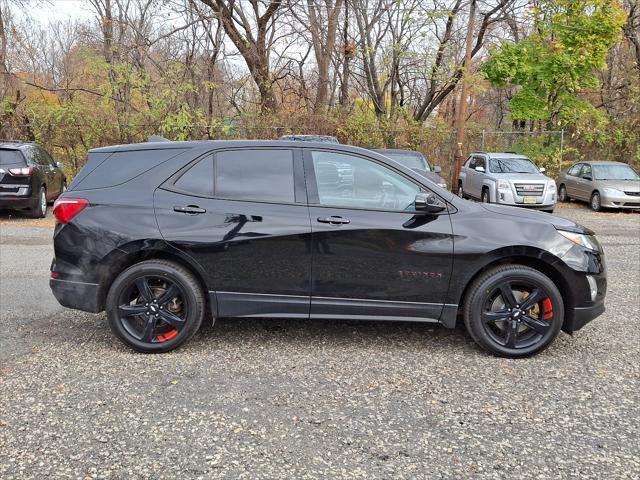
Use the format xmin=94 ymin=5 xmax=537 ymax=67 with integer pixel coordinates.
xmin=557 ymin=162 xmax=640 ymax=212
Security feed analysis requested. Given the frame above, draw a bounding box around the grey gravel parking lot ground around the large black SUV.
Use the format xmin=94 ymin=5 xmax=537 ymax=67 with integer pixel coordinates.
xmin=0 ymin=204 xmax=640 ymax=479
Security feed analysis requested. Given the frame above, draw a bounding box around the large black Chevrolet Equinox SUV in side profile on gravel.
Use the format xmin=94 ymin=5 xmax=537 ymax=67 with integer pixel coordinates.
xmin=50 ymin=140 xmax=606 ymax=357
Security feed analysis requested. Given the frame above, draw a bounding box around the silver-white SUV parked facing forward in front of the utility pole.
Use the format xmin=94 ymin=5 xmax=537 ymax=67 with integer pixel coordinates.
xmin=458 ymin=152 xmax=557 ymax=213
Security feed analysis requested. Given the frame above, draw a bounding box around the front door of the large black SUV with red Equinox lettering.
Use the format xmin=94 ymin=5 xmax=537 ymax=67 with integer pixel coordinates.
xmin=305 ymin=149 xmax=453 ymax=320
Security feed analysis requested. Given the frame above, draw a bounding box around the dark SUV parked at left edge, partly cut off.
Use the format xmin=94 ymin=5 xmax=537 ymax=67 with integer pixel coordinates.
xmin=0 ymin=140 xmax=67 ymax=218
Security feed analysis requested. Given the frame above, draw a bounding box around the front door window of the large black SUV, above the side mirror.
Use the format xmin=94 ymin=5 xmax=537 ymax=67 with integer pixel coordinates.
xmin=312 ymin=151 xmax=420 ymax=211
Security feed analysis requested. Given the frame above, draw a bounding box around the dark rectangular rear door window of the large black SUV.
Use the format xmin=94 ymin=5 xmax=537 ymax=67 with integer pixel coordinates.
xmin=215 ymin=149 xmax=295 ymax=203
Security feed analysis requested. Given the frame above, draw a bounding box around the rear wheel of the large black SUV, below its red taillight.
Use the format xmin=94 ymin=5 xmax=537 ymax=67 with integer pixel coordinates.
xmin=106 ymin=260 xmax=206 ymax=353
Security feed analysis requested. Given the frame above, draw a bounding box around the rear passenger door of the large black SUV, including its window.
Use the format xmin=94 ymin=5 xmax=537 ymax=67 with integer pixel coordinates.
xmin=154 ymin=147 xmax=311 ymax=318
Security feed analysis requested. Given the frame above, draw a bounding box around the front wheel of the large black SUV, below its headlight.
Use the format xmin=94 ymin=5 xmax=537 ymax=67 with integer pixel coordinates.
xmin=463 ymin=265 xmax=564 ymax=358
